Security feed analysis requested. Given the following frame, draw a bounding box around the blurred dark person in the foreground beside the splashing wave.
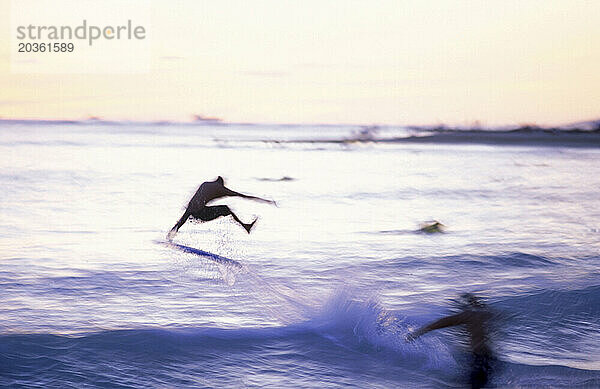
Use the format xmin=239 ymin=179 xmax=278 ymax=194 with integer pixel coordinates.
xmin=406 ymin=293 xmax=496 ymax=388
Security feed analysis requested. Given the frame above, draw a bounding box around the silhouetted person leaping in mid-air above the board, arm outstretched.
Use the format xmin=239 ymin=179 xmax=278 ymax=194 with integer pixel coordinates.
xmin=167 ymin=176 xmax=275 ymax=240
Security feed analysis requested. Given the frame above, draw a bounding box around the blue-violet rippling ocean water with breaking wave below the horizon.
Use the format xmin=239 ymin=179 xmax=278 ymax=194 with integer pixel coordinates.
xmin=0 ymin=123 xmax=600 ymax=388
